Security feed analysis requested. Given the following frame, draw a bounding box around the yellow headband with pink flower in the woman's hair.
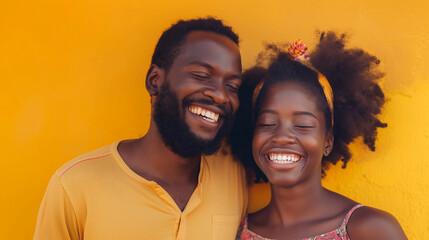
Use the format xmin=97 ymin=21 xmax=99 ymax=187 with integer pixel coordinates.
xmin=252 ymin=39 xmax=334 ymax=126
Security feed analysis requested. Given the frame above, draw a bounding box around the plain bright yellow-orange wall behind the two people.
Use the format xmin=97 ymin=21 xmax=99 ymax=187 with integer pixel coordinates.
xmin=0 ymin=0 xmax=429 ymax=239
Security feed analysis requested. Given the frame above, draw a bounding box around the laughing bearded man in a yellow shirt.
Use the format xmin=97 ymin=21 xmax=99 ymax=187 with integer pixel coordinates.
xmin=34 ymin=18 xmax=247 ymax=240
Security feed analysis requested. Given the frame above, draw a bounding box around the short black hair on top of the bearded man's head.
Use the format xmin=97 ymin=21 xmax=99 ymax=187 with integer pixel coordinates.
xmin=151 ymin=17 xmax=239 ymax=71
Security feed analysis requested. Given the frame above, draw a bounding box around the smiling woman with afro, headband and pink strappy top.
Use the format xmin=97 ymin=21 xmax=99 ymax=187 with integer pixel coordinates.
xmin=230 ymin=32 xmax=406 ymax=240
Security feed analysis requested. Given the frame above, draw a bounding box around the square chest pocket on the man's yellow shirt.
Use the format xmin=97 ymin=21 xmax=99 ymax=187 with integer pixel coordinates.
xmin=211 ymin=215 xmax=240 ymax=240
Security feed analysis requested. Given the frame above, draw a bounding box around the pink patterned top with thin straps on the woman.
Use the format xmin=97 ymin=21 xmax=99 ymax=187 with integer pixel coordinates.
xmin=236 ymin=204 xmax=364 ymax=240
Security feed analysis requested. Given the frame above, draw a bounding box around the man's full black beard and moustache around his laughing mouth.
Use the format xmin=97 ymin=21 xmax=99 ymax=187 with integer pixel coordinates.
xmin=153 ymin=83 xmax=233 ymax=157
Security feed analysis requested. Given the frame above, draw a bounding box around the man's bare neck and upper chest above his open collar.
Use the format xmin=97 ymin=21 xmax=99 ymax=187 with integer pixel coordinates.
xmin=118 ymin=124 xmax=201 ymax=210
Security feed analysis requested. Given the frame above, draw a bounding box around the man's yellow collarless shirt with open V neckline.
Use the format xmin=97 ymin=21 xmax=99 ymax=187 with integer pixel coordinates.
xmin=34 ymin=143 xmax=247 ymax=240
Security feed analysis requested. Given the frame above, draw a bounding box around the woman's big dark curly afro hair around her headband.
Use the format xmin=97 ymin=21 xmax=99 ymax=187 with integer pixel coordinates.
xmin=228 ymin=32 xmax=387 ymax=182
